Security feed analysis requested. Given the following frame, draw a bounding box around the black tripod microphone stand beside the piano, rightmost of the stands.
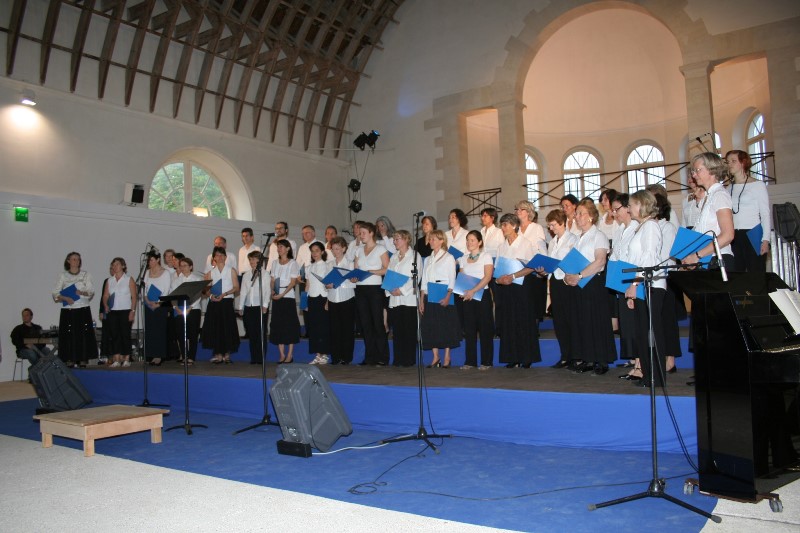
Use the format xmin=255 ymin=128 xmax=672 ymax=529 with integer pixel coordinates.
xmin=589 ymin=265 xmax=722 ymax=523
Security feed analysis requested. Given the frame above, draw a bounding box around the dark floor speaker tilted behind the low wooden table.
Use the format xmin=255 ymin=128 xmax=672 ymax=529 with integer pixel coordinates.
xmin=28 ymin=355 xmax=92 ymax=411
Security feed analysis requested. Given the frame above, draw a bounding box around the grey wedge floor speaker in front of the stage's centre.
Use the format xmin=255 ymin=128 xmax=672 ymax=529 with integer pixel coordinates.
xmin=269 ymin=365 xmax=353 ymax=457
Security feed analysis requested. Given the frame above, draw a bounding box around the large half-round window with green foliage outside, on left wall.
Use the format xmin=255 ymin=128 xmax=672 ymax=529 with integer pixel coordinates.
xmin=147 ymin=160 xmax=231 ymax=218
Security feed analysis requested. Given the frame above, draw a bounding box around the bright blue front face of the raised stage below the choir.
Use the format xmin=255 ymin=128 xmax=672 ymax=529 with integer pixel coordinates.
xmin=76 ymin=363 xmax=697 ymax=454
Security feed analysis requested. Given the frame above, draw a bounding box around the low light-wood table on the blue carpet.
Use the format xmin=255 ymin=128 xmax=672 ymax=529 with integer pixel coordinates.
xmin=33 ymin=405 xmax=169 ymax=457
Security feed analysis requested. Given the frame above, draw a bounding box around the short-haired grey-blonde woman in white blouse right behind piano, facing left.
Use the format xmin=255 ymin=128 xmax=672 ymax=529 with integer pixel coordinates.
xmin=683 ymin=152 xmax=734 ymax=268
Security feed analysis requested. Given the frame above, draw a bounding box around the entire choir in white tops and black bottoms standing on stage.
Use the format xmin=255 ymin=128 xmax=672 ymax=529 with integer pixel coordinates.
xmin=48 ymin=150 xmax=771 ymax=378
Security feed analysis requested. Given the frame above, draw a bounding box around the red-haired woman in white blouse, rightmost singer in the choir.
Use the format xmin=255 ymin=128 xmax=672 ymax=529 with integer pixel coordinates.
xmin=725 ymin=150 xmax=772 ymax=272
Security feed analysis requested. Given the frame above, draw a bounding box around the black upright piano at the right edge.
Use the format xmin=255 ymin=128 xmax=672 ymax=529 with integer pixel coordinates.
xmin=670 ymin=271 xmax=800 ymax=501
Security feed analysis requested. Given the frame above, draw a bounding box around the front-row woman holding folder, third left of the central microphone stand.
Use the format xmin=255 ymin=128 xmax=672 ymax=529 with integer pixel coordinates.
xmin=326 ymin=236 xmax=356 ymax=365
